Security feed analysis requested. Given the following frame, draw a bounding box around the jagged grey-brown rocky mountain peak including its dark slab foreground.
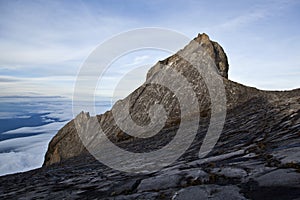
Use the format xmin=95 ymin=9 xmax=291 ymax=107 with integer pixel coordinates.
xmin=0 ymin=34 xmax=300 ymax=200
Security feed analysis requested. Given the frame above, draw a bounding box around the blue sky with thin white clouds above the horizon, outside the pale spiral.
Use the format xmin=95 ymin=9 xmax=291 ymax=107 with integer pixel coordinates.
xmin=0 ymin=0 xmax=300 ymax=97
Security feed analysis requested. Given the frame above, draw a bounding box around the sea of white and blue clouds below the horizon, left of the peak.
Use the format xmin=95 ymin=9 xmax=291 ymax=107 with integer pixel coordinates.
xmin=0 ymin=98 xmax=110 ymax=176
